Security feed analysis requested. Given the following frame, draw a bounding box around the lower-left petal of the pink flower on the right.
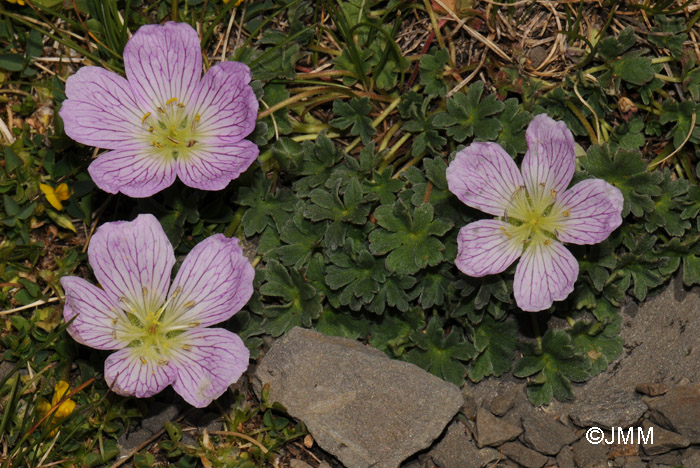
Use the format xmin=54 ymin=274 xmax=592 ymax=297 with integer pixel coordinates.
xmin=455 ymin=219 xmax=523 ymax=277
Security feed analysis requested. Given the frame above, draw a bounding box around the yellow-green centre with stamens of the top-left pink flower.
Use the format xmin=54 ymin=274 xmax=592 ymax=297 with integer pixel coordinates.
xmin=141 ymin=98 xmax=200 ymax=159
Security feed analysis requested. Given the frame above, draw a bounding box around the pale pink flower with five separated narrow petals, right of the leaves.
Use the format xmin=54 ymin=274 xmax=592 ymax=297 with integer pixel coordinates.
xmin=447 ymin=114 xmax=623 ymax=312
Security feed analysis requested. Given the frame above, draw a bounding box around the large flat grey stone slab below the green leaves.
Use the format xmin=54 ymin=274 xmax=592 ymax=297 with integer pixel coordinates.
xmin=252 ymin=328 xmax=463 ymax=468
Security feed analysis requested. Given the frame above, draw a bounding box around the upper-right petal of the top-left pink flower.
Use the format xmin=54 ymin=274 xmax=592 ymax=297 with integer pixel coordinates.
xmin=187 ymin=62 xmax=258 ymax=143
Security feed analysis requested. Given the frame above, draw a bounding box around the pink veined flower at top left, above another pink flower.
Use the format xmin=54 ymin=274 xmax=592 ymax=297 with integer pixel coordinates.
xmin=60 ymin=22 xmax=259 ymax=197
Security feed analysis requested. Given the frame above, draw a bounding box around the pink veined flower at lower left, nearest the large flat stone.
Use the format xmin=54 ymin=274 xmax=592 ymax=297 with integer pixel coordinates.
xmin=61 ymin=215 xmax=255 ymax=408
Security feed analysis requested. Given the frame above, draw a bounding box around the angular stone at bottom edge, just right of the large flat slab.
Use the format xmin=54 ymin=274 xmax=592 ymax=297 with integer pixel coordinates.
xmin=430 ymin=422 xmax=500 ymax=468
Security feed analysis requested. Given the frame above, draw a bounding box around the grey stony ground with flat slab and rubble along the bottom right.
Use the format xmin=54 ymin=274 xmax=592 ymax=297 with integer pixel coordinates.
xmin=110 ymin=274 xmax=700 ymax=468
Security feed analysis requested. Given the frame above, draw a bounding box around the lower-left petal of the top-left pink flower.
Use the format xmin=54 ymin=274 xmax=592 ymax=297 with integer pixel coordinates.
xmin=88 ymin=145 xmax=176 ymax=198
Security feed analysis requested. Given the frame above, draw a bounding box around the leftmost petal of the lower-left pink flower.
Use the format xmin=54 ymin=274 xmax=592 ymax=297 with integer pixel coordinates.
xmin=61 ymin=276 xmax=129 ymax=349
